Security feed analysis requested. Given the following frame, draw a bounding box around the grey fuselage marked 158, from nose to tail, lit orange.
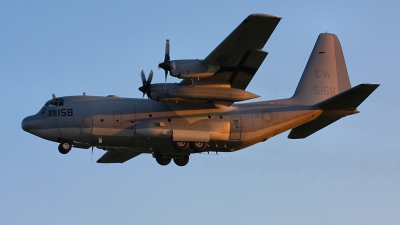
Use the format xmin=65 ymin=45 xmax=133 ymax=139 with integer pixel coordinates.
xmin=22 ymin=96 xmax=322 ymax=154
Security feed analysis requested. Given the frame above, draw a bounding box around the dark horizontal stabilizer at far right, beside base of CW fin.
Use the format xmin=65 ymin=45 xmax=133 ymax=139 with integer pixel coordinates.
xmin=316 ymin=84 xmax=379 ymax=110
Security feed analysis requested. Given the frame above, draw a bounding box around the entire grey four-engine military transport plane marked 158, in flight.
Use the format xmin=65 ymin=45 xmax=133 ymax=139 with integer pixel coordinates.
xmin=22 ymin=14 xmax=379 ymax=166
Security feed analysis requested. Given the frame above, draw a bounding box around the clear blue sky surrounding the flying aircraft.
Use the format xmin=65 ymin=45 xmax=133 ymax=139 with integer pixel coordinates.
xmin=0 ymin=0 xmax=400 ymax=225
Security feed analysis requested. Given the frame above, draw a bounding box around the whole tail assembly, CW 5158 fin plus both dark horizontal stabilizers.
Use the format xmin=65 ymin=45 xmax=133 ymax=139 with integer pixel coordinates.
xmin=288 ymin=33 xmax=379 ymax=139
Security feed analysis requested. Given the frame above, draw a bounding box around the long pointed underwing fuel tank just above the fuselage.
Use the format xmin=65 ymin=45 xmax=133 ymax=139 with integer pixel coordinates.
xmin=169 ymin=86 xmax=260 ymax=102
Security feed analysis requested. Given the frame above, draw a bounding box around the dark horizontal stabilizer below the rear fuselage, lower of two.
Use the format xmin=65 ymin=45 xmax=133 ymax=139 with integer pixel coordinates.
xmin=288 ymin=118 xmax=340 ymax=139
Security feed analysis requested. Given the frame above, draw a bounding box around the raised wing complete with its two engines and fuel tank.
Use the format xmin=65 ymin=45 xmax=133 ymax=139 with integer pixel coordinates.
xmin=145 ymin=14 xmax=281 ymax=106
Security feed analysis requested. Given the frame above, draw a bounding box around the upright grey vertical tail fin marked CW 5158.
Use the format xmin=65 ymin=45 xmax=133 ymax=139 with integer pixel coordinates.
xmin=292 ymin=33 xmax=351 ymax=105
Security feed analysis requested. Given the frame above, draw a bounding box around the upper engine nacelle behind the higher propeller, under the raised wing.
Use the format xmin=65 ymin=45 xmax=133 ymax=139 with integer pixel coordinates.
xmin=171 ymin=59 xmax=220 ymax=79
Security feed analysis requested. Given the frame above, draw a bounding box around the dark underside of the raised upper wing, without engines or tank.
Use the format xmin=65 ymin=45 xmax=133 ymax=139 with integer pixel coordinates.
xmin=200 ymin=14 xmax=281 ymax=90
